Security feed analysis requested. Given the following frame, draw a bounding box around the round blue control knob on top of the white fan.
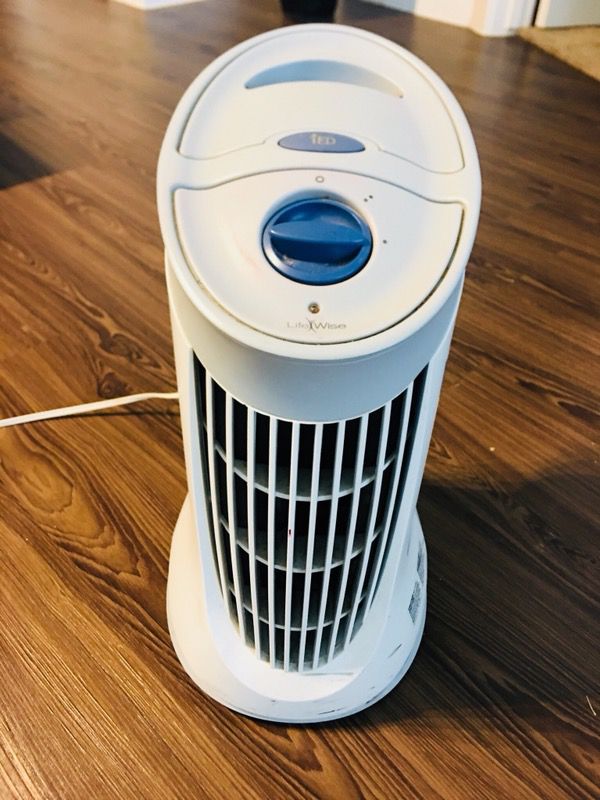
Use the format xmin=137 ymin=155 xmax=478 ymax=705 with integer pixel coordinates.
xmin=263 ymin=198 xmax=373 ymax=286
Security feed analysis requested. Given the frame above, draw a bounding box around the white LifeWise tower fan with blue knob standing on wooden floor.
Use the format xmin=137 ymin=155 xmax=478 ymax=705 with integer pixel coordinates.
xmin=158 ymin=25 xmax=481 ymax=722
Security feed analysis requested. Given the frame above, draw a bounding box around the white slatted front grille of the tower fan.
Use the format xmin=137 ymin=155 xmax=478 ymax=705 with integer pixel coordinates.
xmin=195 ymin=359 xmax=426 ymax=672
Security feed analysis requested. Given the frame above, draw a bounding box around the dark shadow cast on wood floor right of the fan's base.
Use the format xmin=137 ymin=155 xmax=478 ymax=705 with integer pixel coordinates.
xmin=243 ymin=464 xmax=600 ymax=747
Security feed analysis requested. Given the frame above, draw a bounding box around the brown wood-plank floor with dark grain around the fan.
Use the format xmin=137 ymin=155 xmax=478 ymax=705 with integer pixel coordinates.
xmin=0 ymin=0 xmax=600 ymax=800
